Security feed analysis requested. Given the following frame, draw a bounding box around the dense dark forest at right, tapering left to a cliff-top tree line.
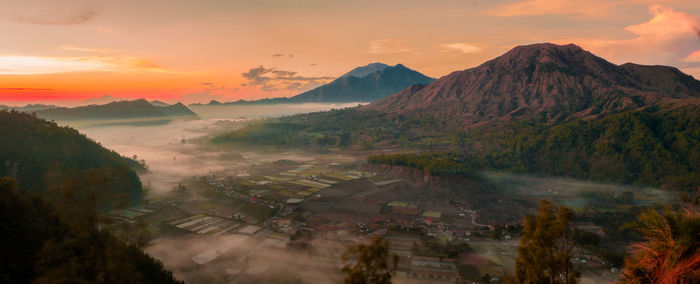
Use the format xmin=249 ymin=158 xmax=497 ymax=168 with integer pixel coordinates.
xmin=367 ymin=105 xmax=700 ymax=192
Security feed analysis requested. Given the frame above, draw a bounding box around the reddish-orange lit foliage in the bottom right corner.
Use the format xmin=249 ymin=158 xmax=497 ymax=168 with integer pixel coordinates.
xmin=620 ymin=201 xmax=700 ymax=283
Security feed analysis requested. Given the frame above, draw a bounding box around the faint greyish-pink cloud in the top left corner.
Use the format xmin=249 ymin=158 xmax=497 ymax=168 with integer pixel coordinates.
xmin=10 ymin=1 xmax=98 ymax=26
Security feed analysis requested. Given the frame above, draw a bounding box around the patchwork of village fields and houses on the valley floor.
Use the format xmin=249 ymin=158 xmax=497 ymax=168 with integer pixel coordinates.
xmin=102 ymin=153 xmax=615 ymax=283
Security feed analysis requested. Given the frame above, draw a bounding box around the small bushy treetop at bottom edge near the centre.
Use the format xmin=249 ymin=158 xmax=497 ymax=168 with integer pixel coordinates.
xmin=342 ymin=238 xmax=398 ymax=284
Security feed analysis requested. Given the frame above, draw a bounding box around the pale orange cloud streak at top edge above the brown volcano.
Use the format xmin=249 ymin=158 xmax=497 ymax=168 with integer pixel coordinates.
xmin=486 ymin=0 xmax=622 ymax=18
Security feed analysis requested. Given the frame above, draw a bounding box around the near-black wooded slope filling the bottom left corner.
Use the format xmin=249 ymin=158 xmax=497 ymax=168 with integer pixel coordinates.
xmin=0 ymin=178 xmax=182 ymax=283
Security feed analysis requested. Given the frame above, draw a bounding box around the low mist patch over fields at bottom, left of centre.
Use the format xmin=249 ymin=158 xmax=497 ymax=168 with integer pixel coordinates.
xmin=146 ymin=235 xmax=346 ymax=283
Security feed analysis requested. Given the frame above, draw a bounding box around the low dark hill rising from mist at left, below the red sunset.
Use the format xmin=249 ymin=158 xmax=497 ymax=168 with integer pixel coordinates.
xmin=36 ymin=99 xmax=198 ymax=123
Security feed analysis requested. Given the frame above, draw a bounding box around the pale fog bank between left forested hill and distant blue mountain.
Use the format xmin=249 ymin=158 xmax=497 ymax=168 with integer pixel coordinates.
xmin=74 ymin=104 xmax=356 ymax=195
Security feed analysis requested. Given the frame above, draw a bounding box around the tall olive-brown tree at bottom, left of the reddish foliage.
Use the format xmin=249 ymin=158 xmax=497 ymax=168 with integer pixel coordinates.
xmin=510 ymin=200 xmax=579 ymax=283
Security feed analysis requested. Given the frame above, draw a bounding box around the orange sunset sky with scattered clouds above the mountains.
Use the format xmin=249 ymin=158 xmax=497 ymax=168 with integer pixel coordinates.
xmin=0 ymin=0 xmax=700 ymax=105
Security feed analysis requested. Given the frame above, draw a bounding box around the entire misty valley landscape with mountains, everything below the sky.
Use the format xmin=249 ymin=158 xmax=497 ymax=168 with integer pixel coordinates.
xmin=0 ymin=43 xmax=700 ymax=283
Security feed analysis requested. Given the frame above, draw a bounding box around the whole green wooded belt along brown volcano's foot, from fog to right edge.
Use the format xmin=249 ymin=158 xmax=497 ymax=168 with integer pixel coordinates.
xmin=212 ymin=100 xmax=700 ymax=191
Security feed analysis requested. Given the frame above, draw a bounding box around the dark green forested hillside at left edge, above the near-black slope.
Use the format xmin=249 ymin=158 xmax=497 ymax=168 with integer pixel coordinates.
xmin=0 ymin=111 xmax=143 ymax=202
